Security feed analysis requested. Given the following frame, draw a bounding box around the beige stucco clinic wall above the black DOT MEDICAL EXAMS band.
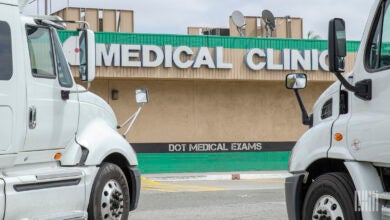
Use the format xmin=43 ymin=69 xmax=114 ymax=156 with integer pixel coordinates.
xmin=73 ymin=45 xmax=355 ymax=143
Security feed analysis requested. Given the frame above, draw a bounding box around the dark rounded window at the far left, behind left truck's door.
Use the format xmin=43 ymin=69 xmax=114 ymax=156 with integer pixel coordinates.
xmin=0 ymin=21 xmax=13 ymax=80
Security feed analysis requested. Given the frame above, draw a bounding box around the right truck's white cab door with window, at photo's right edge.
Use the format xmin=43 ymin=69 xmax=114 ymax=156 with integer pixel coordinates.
xmin=348 ymin=1 xmax=390 ymax=163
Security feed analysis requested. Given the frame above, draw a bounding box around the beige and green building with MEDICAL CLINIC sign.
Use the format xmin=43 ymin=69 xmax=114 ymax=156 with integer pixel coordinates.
xmin=54 ymin=6 xmax=359 ymax=173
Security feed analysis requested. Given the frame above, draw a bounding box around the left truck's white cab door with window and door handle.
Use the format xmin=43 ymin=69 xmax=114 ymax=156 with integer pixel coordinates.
xmin=24 ymin=26 xmax=79 ymax=151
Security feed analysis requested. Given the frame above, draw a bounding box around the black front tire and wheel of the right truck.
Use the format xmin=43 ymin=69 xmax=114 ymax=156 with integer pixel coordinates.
xmin=302 ymin=172 xmax=362 ymax=220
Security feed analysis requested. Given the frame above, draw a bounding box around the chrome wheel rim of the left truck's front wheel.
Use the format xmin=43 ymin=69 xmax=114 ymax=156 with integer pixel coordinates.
xmin=100 ymin=180 xmax=123 ymax=220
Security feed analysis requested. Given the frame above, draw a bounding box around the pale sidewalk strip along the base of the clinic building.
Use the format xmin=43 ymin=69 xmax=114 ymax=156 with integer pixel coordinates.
xmin=142 ymin=171 xmax=291 ymax=182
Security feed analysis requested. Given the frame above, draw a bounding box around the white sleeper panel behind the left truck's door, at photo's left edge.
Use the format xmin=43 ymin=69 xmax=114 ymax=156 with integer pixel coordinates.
xmin=0 ymin=4 xmax=26 ymax=153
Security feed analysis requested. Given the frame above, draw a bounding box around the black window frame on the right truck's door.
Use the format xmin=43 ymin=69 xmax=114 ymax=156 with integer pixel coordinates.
xmin=364 ymin=0 xmax=390 ymax=73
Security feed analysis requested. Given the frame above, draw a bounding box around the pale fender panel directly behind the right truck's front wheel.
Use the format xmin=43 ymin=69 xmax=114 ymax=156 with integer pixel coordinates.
xmin=344 ymin=161 xmax=384 ymax=220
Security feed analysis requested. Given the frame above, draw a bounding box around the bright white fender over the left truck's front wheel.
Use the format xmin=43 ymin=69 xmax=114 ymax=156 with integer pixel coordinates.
xmin=76 ymin=118 xmax=138 ymax=166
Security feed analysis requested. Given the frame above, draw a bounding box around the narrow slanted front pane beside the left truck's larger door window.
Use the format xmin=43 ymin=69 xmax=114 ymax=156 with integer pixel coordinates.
xmin=53 ymin=31 xmax=73 ymax=88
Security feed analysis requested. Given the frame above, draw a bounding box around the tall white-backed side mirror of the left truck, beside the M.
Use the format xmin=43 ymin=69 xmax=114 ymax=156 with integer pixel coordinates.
xmin=79 ymin=29 xmax=96 ymax=82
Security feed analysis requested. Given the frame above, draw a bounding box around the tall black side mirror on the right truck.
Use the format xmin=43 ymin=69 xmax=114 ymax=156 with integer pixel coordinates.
xmin=328 ymin=18 xmax=347 ymax=73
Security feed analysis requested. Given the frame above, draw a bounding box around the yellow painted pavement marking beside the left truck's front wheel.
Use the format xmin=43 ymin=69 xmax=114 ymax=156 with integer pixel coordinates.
xmin=141 ymin=177 xmax=225 ymax=192
